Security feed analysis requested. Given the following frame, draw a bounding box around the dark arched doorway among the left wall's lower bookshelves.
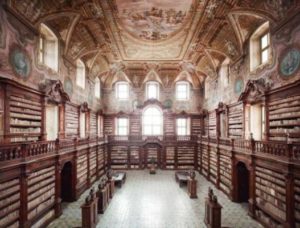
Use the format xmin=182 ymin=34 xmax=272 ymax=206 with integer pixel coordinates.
xmin=60 ymin=162 xmax=73 ymax=202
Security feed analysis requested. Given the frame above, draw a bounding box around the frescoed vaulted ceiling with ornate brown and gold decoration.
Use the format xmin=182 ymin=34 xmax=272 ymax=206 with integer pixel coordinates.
xmin=8 ymin=0 xmax=299 ymax=81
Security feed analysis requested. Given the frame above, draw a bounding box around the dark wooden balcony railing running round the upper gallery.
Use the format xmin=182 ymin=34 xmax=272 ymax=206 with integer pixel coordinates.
xmin=0 ymin=135 xmax=300 ymax=162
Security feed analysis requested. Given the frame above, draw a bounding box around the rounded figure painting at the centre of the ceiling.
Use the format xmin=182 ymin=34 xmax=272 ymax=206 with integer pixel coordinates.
xmin=116 ymin=0 xmax=193 ymax=41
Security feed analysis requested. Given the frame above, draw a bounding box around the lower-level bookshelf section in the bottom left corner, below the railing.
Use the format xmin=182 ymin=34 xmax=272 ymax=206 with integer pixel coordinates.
xmin=0 ymin=178 xmax=20 ymax=227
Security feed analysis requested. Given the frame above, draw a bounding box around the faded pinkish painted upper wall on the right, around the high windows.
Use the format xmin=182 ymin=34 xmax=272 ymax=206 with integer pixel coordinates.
xmin=204 ymin=13 xmax=300 ymax=110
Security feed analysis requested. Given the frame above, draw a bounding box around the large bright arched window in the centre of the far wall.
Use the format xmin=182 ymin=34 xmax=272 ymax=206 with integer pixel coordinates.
xmin=143 ymin=106 xmax=163 ymax=135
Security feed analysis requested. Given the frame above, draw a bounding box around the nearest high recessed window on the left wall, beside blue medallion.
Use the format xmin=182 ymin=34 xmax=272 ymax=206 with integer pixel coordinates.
xmin=39 ymin=24 xmax=58 ymax=71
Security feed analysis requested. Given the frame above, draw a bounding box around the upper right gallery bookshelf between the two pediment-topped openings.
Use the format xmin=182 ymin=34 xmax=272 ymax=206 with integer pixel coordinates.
xmin=228 ymin=102 xmax=244 ymax=138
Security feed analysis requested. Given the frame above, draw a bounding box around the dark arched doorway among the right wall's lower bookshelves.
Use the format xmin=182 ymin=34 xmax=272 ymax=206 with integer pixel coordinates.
xmin=236 ymin=162 xmax=249 ymax=203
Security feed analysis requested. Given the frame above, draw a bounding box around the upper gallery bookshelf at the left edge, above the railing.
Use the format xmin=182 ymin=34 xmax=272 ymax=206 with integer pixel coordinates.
xmin=0 ymin=78 xmax=45 ymax=143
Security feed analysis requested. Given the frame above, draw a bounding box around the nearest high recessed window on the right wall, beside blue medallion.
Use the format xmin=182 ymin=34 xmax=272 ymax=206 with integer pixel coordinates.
xmin=250 ymin=22 xmax=272 ymax=71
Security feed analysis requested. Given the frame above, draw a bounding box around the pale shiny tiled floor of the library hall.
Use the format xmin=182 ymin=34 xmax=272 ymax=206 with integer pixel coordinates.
xmin=49 ymin=170 xmax=261 ymax=228
